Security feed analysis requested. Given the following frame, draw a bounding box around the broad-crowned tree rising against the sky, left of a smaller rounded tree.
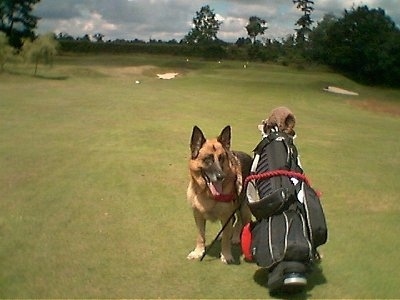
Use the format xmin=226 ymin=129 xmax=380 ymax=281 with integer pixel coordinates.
xmin=184 ymin=5 xmax=222 ymax=44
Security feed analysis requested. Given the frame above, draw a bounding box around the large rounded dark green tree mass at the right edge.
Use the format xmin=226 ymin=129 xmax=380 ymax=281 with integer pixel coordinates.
xmin=310 ymin=6 xmax=400 ymax=86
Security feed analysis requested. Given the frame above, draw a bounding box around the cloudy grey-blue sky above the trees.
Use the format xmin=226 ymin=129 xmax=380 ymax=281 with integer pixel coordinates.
xmin=33 ymin=0 xmax=400 ymax=42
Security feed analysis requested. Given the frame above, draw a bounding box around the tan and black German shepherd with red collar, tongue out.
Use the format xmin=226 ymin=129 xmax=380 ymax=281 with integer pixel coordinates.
xmin=187 ymin=126 xmax=252 ymax=263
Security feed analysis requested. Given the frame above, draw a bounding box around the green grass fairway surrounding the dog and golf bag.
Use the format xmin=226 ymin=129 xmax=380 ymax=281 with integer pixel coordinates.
xmin=0 ymin=56 xmax=400 ymax=298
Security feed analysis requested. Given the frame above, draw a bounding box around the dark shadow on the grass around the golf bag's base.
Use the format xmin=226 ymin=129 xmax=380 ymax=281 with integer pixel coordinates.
xmin=253 ymin=263 xmax=327 ymax=299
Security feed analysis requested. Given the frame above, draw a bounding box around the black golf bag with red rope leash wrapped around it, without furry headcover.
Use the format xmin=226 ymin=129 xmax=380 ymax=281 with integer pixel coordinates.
xmin=242 ymin=130 xmax=327 ymax=292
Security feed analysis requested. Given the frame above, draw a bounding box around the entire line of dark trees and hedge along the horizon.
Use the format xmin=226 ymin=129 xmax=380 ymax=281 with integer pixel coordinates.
xmin=0 ymin=0 xmax=400 ymax=87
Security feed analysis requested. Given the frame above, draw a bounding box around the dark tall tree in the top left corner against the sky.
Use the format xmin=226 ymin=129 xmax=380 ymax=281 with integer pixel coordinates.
xmin=0 ymin=0 xmax=40 ymax=48
